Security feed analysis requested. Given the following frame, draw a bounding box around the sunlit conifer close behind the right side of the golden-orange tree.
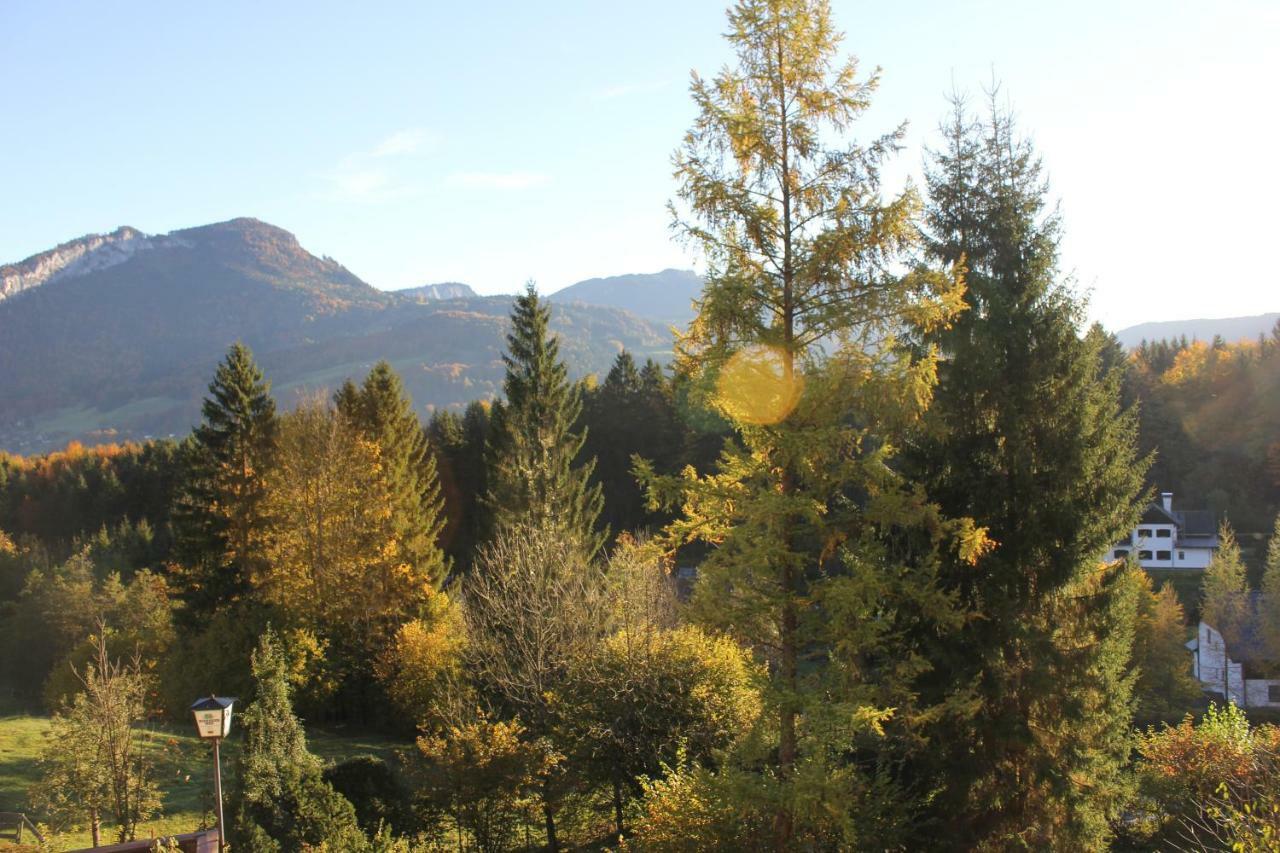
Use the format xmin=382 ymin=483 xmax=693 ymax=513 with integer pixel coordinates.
xmin=334 ymin=361 xmax=445 ymax=585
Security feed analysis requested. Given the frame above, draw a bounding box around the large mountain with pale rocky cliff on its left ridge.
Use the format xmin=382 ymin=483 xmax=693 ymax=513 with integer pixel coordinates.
xmin=0 ymin=219 xmax=671 ymax=452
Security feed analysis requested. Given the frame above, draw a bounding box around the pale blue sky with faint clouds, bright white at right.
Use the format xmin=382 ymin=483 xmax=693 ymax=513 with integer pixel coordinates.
xmin=0 ymin=0 xmax=1280 ymax=329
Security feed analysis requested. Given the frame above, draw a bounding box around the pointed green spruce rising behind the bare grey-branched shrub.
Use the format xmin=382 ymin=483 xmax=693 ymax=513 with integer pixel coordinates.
xmin=484 ymin=283 xmax=607 ymax=555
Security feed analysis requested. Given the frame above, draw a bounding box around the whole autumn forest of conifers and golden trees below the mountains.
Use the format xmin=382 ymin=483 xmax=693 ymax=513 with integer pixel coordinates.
xmin=0 ymin=0 xmax=1280 ymax=852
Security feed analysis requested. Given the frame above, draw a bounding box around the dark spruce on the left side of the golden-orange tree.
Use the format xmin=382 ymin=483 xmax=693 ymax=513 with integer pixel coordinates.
xmin=174 ymin=343 xmax=275 ymax=615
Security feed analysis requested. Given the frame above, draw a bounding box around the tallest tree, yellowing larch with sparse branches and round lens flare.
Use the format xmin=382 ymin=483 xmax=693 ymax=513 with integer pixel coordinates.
xmin=650 ymin=0 xmax=967 ymax=849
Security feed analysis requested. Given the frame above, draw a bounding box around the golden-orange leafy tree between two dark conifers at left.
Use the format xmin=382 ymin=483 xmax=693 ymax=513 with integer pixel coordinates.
xmin=253 ymin=401 xmax=439 ymax=713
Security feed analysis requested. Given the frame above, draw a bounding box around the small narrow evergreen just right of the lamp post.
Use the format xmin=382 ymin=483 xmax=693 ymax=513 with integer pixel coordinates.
xmin=230 ymin=628 xmax=369 ymax=853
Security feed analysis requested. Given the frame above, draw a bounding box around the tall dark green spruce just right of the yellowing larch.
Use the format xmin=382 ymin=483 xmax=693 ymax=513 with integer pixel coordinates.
xmin=915 ymin=95 xmax=1146 ymax=849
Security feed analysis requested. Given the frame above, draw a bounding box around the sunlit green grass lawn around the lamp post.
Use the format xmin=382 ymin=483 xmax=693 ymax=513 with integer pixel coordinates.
xmin=0 ymin=715 xmax=408 ymax=850
